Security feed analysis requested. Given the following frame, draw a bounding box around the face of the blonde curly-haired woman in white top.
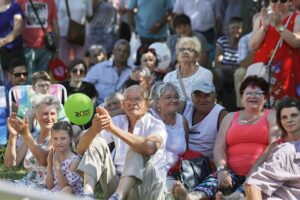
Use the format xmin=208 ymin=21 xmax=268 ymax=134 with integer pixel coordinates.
xmin=177 ymin=43 xmax=198 ymax=63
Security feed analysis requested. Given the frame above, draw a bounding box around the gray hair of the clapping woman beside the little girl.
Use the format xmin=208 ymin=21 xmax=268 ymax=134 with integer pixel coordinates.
xmin=32 ymin=94 xmax=60 ymax=113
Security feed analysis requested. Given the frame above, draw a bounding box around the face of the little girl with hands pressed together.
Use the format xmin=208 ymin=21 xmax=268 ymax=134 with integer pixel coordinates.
xmin=51 ymin=130 xmax=72 ymax=153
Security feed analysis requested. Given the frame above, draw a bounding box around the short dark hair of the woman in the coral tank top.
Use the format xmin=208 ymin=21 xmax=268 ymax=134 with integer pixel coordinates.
xmin=240 ymin=76 xmax=269 ymax=96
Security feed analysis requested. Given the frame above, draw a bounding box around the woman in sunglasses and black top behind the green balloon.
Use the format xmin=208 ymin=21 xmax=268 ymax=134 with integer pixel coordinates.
xmin=61 ymin=59 xmax=98 ymax=104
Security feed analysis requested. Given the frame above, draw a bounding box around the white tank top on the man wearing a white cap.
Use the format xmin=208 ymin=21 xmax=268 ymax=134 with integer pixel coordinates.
xmin=183 ymin=103 xmax=224 ymax=159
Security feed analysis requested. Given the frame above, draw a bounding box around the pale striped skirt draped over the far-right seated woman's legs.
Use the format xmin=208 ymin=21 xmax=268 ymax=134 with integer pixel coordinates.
xmin=246 ymin=141 xmax=300 ymax=200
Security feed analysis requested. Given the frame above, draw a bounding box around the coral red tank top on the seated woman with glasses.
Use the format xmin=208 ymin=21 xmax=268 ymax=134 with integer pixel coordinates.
xmin=226 ymin=110 xmax=270 ymax=176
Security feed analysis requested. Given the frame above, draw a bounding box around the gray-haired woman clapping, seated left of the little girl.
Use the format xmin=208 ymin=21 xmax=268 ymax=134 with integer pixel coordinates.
xmin=4 ymin=95 xmax=60 ymax=188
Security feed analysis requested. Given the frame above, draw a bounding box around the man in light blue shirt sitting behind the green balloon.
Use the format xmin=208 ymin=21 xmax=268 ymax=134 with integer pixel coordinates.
xmin=84 ymin=39 xmax=133 ymax=105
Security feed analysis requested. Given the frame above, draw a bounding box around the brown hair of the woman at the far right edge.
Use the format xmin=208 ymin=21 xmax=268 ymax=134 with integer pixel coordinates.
xmin=276 ymin=97 xmax=300 ymax=138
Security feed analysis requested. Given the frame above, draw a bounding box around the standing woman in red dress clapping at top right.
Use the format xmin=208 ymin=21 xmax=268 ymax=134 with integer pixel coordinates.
xmin=249 ymin=0 xmax=300 ymax=104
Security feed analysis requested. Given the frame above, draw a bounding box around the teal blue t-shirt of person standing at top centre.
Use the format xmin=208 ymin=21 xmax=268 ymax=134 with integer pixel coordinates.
xmin=128 ymin=0 xmax=173 ymax=38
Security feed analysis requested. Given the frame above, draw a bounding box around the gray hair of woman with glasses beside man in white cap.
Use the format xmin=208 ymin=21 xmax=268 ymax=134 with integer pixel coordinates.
xmin=151 ymin=82 xmax=179 ymax=101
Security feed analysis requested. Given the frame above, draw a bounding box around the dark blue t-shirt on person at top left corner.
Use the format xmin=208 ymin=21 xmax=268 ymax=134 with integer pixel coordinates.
xmin=0 ymin=3 xmax=23 ymax=49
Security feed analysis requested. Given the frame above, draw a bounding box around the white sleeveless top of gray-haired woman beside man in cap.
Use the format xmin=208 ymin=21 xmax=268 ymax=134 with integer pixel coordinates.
xmin=150 ymin=108 xmax=186 ymax=170
